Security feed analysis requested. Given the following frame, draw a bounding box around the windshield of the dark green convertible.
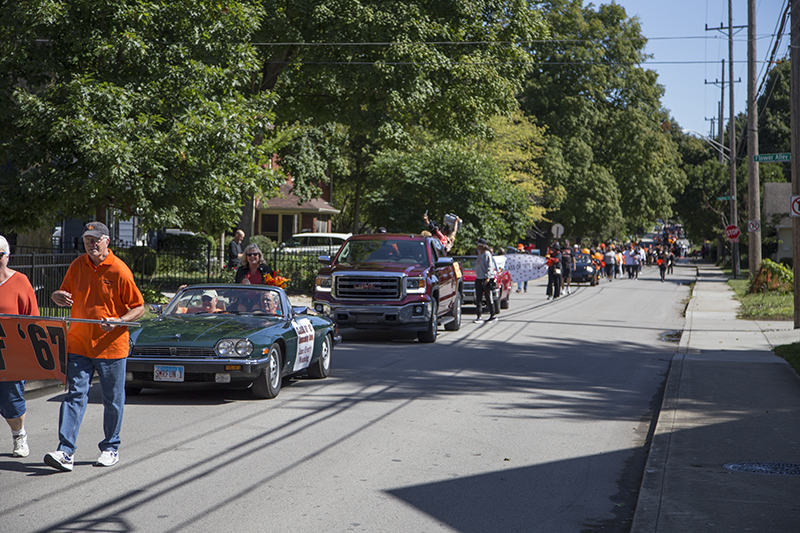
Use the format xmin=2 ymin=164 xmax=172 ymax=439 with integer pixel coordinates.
xmin=164 ymin=285 xmax=284 ymax=316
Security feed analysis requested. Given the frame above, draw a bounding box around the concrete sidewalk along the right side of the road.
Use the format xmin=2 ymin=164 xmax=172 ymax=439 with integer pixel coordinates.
xmin=631 ymin=264 xmax=800 ymax=533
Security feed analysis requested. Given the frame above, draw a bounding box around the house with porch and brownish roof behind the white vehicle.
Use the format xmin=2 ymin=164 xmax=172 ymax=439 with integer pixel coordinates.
xmin=245 ymin=180 xmax=339 ymax=243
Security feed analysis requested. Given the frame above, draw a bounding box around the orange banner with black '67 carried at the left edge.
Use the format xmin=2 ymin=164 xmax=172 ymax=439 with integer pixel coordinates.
xmin=0 ymin=315 xmax=67 ymax=383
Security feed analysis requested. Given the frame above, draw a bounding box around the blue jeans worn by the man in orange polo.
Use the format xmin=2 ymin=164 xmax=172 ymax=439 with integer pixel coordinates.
xmin=58 ymin=353 xmax=127 ymax=454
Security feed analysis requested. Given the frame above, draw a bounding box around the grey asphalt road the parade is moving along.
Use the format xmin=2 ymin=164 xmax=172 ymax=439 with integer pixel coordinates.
xmin=0 ymin=267 xmax=690 ymax=532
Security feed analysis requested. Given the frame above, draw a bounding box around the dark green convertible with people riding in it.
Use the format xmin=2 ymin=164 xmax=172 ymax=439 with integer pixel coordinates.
xmin=125 ymin=284 xmax=341 ymax=398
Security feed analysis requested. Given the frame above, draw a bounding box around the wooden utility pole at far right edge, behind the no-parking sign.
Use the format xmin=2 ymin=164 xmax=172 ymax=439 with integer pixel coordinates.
xmin=789 ymin=0 xmax=800 ymax=329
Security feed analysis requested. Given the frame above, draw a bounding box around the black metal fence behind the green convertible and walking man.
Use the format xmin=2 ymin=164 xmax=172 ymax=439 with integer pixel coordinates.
xmin=9 ymin=243 xmax=321 ymax=316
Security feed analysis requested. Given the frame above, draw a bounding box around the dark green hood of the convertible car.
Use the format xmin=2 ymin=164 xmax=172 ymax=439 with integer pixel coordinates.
xmin=131 ymin=315 xmax=283 ymax=346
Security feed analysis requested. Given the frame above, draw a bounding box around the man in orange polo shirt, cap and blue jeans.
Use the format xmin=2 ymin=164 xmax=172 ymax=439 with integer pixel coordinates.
xmin=44 ymin=222 xmax=144 ymax=472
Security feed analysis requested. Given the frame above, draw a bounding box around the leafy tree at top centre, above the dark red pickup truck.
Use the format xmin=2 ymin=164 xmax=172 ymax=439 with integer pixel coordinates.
xmin=254 ymin=0 xmax=546 ymax=231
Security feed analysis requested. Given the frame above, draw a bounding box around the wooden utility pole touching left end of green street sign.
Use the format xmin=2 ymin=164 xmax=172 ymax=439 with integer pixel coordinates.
xmin=748 ymin=0 xmax=761 ymax=279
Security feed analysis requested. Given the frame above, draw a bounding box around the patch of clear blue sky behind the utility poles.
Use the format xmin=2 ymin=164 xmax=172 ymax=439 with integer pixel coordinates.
xmin=584 ymin=0 xmax=789 ymax=137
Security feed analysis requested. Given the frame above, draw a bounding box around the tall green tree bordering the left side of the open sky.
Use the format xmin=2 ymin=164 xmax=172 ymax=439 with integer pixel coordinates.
xmin=521 ymin=0 xmax=685 ymax=240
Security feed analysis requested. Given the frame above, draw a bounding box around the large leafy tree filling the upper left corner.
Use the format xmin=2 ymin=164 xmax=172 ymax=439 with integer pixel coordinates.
xmin=0 ymin=0 xmax=282 ymax=233
